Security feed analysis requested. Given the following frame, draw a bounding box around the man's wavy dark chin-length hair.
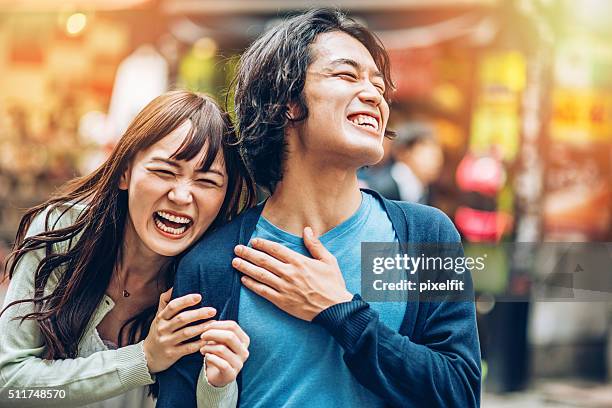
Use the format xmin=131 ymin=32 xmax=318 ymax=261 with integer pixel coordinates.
xmin=234 ymin=8 xmax=394 ymax=192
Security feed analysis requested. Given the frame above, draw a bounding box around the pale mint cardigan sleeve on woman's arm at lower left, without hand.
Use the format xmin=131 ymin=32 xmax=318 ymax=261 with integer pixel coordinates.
xmin=0 ymin=217 xmax=153 ymax=407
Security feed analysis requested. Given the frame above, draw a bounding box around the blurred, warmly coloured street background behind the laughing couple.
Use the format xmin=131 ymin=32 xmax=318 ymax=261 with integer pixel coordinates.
xmin=0 ymin=0 xmax=612 ymax=407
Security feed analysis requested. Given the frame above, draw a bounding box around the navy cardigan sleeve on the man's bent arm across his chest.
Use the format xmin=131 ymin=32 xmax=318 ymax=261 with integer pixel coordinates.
xmin=313 ymin=215 xmax=481 ymax=407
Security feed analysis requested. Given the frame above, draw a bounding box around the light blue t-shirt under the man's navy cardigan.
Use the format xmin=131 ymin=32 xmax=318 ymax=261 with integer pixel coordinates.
xmin=238 ymin=192 xmax=406 ymax=408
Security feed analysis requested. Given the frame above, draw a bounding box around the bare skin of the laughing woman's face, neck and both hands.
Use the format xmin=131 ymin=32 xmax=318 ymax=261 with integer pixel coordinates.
xmin=104 ymin=122 xmax=249 ymax=387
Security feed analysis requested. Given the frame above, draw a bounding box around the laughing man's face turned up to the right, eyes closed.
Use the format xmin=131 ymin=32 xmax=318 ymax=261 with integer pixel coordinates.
xmin=290 ymin=32 xmax=389 ymax=168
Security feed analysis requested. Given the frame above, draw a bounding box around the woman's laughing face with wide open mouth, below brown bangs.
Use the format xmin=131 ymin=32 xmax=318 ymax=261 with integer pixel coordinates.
xmin=119 ymin=121 xmax=227 ymax=256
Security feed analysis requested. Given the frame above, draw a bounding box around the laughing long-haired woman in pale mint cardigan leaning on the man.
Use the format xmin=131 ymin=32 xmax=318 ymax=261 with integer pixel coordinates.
xmin=0 ymin=91 xmax=254 ymax=407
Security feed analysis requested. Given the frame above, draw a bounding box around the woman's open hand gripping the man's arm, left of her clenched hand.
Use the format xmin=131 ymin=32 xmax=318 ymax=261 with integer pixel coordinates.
xmin=144 ymin=288 xmax=217 ymax=374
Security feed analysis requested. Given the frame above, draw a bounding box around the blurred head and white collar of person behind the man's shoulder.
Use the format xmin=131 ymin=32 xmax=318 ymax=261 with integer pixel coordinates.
xmin=390 ymin=122 xmax=444 ymax=204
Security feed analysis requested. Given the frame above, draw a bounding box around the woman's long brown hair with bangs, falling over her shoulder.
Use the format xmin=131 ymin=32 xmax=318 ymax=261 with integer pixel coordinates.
xmin=0 ymin=91 xmax=255 ymax=388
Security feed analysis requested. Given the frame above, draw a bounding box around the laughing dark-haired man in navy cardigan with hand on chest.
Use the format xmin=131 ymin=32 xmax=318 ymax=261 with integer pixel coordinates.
xmin=158 ymin=9 xmax=481 ymax=407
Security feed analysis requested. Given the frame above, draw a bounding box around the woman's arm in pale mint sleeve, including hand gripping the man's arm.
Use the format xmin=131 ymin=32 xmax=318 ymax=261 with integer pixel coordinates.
xmin=0 ymin=209 xmax=222 ymax=406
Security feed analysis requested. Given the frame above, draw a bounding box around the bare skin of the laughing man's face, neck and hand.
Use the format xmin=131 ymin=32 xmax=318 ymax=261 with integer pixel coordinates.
xmin=233 ymin=32 xmax=389 ymax=321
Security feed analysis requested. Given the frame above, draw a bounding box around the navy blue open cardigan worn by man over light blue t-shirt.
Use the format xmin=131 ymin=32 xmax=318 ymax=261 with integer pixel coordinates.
xmin=157 ymin=191 xmax=481 ymax=408
